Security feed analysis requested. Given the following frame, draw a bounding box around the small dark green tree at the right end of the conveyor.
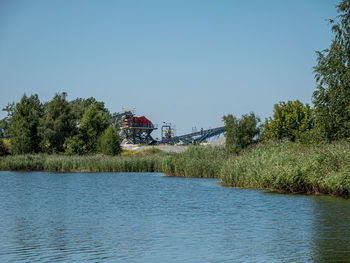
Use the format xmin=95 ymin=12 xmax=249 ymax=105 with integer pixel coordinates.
xmin=223 ymin=112 xmax=260 ymax=152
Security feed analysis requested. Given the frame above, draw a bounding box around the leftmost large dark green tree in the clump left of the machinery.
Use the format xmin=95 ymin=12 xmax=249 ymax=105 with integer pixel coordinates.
xmin=9 ymin=94 xmax=42 ymax=154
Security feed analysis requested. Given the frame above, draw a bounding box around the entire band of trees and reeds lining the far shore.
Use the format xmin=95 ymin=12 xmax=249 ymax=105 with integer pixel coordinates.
xmin=0 ymin=0 xmax=350 ymax=200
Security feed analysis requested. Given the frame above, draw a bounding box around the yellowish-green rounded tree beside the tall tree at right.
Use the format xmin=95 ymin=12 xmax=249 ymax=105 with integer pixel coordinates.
xmin=262 ymin=100 xmax=314 ymax=141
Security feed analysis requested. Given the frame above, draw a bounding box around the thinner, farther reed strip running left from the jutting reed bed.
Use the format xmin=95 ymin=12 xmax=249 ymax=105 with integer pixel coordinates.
xmin=0 ymin=147 xmax=225 ymax=178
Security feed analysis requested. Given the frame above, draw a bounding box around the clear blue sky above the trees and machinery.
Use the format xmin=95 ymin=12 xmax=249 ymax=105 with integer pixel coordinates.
xmin=0 ymin=0 xmax=339 ymax=138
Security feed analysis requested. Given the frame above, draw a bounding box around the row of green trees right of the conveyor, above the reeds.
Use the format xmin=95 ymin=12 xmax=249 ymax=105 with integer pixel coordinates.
xmin=223 ymin=0 xmax=350 ymax=152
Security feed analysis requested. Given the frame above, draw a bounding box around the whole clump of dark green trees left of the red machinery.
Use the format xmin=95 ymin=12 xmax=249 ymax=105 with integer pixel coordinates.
xmin=0 ymin=93 xmax=121 ymax=155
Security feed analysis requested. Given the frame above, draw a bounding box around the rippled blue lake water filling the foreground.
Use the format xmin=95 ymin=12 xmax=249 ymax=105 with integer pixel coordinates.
xmin=0 ymin=172 xmax=350 ymax=263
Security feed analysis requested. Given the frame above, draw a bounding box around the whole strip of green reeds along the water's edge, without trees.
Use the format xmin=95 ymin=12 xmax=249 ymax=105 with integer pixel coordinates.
xmin=0 ymin=141 xmax=350 ymax=198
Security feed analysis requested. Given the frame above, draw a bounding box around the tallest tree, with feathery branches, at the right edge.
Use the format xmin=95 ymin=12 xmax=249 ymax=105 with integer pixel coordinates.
xmin=313 ymin=0 xmax=350 ymax=141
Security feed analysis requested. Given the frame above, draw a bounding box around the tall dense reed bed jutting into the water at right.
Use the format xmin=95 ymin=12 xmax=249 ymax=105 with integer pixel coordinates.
xmin=220 ymin=142 xmax=350 ymax=197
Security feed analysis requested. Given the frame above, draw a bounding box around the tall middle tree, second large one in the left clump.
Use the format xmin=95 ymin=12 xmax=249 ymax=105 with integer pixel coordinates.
xmin=39 ymin=93 xmax=76 ymax=153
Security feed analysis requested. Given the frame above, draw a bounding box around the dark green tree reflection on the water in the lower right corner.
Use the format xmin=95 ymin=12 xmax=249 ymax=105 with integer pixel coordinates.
xmin=312 ymin=196 xmax=350 ymax=262
